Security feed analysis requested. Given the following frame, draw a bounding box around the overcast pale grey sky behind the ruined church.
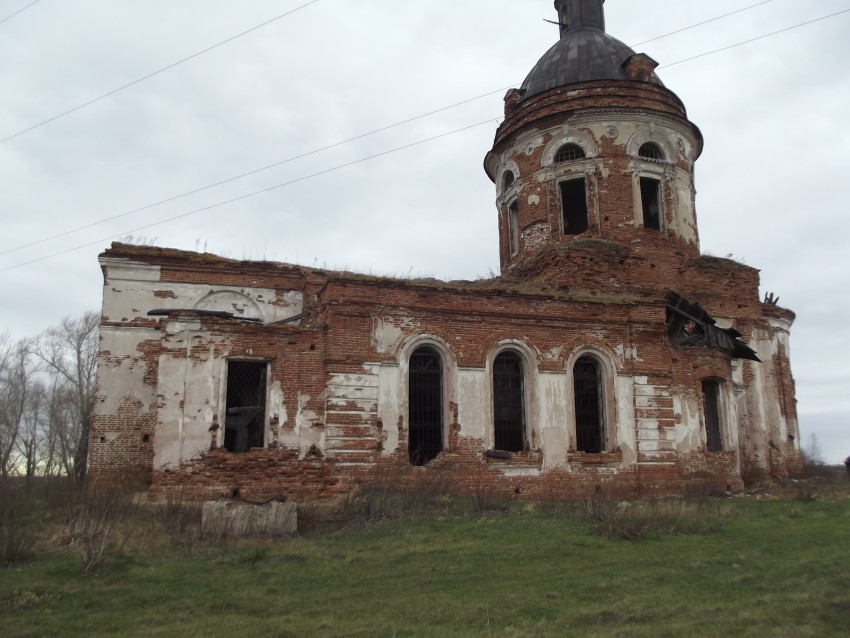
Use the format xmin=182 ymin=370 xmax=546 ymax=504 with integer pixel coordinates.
xmin=0 ymin=0 xmax=850 ymax=462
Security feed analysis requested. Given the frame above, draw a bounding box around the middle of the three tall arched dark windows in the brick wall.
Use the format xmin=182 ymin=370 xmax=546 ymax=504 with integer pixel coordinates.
xmin=493 ymin=352 xmax=525 ymax=452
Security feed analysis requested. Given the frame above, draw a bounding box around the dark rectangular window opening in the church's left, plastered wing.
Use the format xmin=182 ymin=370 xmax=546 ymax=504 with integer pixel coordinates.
xmin=224 ymin=361 xmax=268 ymax=452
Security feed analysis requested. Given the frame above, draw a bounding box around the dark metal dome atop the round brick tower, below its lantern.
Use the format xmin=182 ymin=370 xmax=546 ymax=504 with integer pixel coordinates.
xmin=522 ymin=27 xmax=660 ymax=98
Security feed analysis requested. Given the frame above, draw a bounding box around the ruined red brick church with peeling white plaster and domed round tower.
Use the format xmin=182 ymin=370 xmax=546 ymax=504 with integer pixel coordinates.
xmin=89 ymin=0 xmax=800 ymax=499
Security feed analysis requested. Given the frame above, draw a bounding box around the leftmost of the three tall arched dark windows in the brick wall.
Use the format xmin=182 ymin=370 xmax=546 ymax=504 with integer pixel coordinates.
xmin=407 ymin=346 xmax=443 ymax=465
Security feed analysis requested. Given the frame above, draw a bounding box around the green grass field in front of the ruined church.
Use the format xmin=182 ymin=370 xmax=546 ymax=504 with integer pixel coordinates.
xmin=0 ymin=488 xmax=850 ymax=637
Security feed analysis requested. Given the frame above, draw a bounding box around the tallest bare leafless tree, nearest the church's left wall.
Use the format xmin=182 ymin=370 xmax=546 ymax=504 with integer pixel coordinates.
xmin=33 ymin=312 xmax=99 ymax=482
